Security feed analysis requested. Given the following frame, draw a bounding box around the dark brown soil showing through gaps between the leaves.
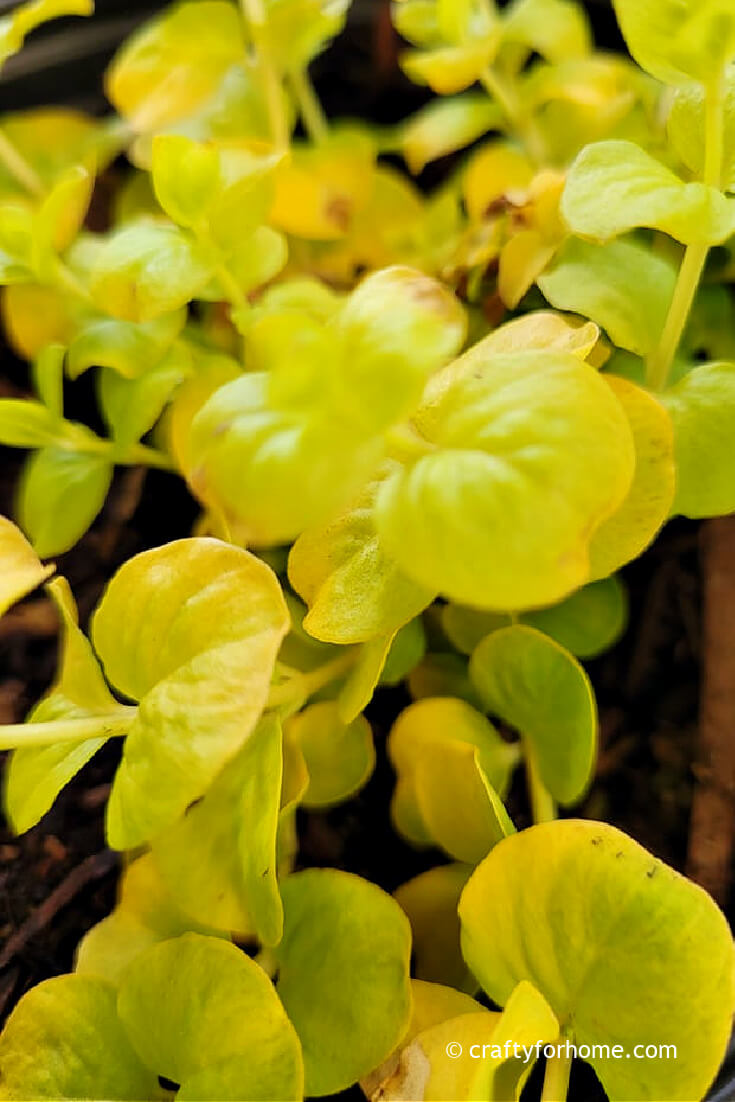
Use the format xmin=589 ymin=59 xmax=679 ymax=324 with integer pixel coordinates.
xmin=0 ymin=0 xmax=732 ymax=1102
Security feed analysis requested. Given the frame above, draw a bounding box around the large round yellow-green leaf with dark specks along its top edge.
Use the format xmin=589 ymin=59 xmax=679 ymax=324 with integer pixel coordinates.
xmin=460 ymin=820 xmax=735 ymax=1102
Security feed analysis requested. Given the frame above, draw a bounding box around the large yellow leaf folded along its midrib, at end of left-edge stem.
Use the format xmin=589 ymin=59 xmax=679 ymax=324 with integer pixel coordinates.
xmin=91 ymin=539 xmax=289 ymax=849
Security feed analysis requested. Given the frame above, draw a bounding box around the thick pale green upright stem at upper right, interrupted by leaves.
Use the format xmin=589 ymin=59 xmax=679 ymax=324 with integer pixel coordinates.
xmin=647 ymin=73 xmax=725 ymax=390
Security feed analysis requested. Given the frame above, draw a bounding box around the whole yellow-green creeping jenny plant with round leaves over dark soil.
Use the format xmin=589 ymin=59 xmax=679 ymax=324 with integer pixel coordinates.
xmin=0 ymin=0 xmax=735 ymax=1102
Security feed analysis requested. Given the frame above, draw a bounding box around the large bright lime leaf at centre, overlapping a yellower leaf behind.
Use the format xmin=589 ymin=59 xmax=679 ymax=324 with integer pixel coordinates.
xmin=376 ymin=342 xmax=634 ymax=611
